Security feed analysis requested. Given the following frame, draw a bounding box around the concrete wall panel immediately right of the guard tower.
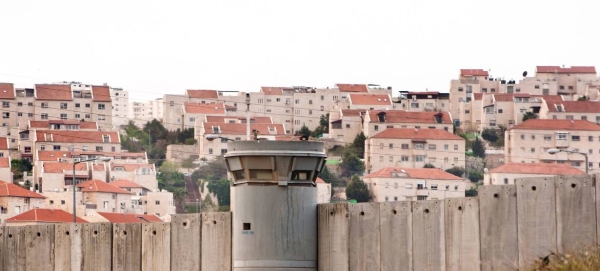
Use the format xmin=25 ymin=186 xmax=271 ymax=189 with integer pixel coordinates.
xmin=318 ymin=203 xmax=350 ymax=271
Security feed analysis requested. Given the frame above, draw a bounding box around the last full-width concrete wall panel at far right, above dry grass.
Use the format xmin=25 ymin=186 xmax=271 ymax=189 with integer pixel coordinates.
xmin=556 ymin=175 xmax=597 ymax=252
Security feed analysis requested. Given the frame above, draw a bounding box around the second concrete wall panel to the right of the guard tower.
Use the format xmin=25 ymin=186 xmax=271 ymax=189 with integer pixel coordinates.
xmin=348 ymin=202 xmax=380 ymax=271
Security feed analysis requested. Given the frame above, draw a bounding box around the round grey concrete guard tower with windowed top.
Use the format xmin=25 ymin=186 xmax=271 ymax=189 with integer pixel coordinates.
xmin=225 ymin=141 xmax=326 ymax=271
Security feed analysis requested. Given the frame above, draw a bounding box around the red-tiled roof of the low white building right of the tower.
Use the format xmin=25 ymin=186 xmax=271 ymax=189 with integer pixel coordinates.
xmin=363 ymin=167 xmax=462 ymax=181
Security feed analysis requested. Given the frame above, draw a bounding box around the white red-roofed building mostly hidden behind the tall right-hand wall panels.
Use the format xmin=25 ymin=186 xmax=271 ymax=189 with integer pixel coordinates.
xmin=483 ymin=163 xmax=585 ymax=185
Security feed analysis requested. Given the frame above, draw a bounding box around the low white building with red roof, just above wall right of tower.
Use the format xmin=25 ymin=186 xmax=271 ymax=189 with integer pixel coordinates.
xmin=363 ymin=167 xmax=465 ymax=202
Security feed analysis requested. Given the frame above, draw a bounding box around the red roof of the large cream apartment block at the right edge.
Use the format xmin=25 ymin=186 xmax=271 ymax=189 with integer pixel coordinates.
xmin=508 ymin=119 xmax=600 ymax=131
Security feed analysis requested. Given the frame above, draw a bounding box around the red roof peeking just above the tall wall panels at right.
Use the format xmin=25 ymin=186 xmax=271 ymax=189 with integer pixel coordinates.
xmin=490 ymin=163 xmax=585 ymax=175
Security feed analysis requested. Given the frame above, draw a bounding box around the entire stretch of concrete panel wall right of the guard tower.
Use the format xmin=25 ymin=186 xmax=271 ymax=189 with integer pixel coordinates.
xmin=318 ymin=175 xmax=600 ymax=271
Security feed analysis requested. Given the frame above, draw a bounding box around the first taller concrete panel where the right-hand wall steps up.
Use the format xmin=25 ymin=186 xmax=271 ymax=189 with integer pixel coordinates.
xmin=479 ymin=185 xmax=519 ymax=271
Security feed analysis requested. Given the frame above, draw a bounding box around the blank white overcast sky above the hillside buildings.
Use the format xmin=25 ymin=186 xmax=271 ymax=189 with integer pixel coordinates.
xmin=0 ymin=0 xmax=600 ymax=99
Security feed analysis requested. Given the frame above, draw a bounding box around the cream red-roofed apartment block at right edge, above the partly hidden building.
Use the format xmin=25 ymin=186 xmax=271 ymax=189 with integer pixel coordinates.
xmin=504 ymin=119 xmax=600 ymax=173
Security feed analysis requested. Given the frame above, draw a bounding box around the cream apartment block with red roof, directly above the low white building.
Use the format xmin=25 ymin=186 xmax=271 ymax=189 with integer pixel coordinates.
xmin=365 ymin=128 xmax=465 ymax=173
